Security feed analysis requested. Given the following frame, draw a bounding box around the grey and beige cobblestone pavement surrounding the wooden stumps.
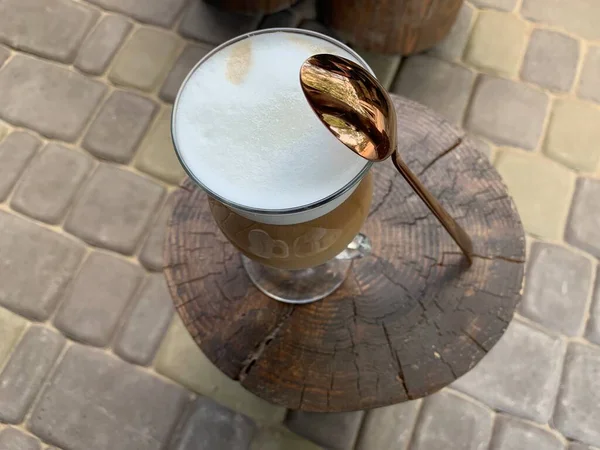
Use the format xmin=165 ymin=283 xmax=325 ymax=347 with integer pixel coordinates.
xmin=0 ymin=0 xmax=600 ymax=450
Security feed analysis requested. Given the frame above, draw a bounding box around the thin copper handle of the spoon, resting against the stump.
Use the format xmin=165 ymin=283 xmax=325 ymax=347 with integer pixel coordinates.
xmin=392 ymin=151 xmax=473 ymax=264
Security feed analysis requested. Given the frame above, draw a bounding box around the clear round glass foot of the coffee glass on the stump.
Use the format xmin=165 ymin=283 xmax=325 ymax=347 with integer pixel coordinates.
xmin=242 ymin=255 xmax=352 ymax=304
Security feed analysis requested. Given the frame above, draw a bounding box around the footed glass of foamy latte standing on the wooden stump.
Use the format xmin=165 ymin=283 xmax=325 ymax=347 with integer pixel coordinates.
xmin=172 ymin=29 xmax=372 ymax=303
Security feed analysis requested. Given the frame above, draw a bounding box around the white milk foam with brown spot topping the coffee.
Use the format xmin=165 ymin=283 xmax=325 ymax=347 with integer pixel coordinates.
xmin=173 ymin=31 xmax=366 ymax=210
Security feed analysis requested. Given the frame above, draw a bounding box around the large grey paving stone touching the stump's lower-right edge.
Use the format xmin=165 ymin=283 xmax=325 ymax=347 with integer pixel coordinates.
xmin=453 ymin=320 xmax=565 ymax=423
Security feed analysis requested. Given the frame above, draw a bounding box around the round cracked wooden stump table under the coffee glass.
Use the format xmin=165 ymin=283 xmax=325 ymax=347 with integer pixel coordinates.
xmin=165 ymin=96 xmax=525 ymax=412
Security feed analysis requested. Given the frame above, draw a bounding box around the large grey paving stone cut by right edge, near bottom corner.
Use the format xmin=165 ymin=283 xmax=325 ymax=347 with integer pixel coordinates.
xmin=554 ymin=343 xmax=600 ymax=445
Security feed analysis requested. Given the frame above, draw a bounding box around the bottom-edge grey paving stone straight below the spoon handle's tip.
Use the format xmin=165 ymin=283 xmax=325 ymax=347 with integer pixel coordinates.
xmin=410 ymin=391 xmax=493 ymax=450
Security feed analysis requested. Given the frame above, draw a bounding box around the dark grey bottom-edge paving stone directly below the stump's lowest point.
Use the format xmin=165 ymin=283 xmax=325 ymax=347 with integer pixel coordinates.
xmin=285 ymin=411 xmax=364 ymax=450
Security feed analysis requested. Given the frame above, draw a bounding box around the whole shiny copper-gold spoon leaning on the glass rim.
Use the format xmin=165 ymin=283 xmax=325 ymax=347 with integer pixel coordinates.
xmin=300 ymin=54 xmax=473 ymax=264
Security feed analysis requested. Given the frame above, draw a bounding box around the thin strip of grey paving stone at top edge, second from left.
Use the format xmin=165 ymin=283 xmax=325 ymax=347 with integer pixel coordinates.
xmin=89 ymin=0 xmax=186 ymax=27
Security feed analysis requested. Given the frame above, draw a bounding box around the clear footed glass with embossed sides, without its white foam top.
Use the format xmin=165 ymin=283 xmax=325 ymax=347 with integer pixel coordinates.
xmin=172 ymin=28 xmax=373 ymax=303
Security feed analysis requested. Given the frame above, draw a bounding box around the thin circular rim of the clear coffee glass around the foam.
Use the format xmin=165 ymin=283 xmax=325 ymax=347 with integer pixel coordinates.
xmin=171 ymin=27 xmax=373 ymax=215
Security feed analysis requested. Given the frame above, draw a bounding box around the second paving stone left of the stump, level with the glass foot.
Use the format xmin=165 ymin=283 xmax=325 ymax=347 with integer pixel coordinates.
xmin=54 ymin=252 xmax=142 ymax=347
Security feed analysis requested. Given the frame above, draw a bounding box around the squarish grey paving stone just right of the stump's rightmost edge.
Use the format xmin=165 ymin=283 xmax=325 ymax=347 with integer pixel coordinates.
xmin=520 ymin=242 xmax=592 ymax=336
